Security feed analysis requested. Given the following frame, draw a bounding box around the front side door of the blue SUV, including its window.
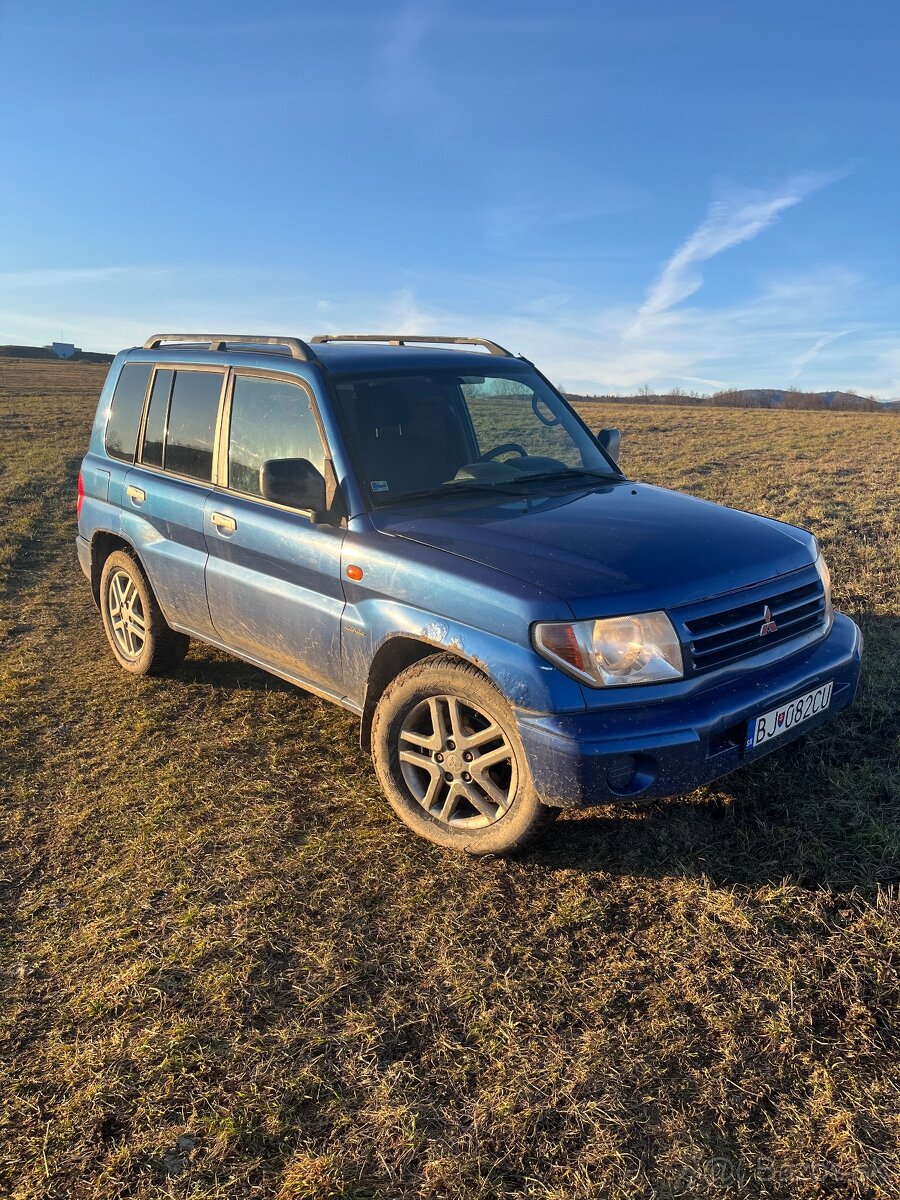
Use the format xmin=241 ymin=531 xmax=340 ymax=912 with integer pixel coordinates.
xmin=204 ymin=368 xmax=344 ymax=697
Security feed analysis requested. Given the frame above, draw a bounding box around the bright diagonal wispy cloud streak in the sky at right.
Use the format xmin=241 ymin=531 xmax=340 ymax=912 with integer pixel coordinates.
xmin=628 ymin=170 xmax=847 ymax=336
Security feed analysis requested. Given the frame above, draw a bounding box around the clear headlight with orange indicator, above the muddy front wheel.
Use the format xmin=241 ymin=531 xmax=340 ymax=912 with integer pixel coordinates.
xmin=534 ymin=612 xmax=684 ymax=688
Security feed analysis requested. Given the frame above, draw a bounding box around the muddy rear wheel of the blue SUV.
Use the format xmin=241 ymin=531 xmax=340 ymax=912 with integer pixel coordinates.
xmin=100 ymin=550 xmax=191 ymax=674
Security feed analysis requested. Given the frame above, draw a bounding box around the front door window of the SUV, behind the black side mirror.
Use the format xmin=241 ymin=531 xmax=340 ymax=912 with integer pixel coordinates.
xmin=228 ymin=376 xmax=325 ymax=496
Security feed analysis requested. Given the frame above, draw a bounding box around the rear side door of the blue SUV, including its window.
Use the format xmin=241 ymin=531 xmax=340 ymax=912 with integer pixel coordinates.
xmin=121 ymin=365 xmax=226 ymax=637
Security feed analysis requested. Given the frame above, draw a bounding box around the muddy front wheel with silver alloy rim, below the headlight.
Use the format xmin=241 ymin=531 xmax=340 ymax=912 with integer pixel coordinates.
xmin=372 ymin=655 xmax=559 ymax=854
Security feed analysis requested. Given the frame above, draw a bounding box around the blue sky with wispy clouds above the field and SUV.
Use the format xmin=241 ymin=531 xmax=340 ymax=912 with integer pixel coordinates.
xmin=0 ymin=0 xmax=900 ymax=397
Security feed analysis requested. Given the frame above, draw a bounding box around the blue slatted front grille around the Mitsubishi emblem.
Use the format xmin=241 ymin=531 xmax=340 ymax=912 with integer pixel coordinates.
xmin=683 ymin=574 xmax=826 ymax=674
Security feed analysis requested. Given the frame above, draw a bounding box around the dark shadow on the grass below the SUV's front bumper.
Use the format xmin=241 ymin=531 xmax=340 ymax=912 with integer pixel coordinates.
xmin=522 ymin=733 xmax=900 ymax=890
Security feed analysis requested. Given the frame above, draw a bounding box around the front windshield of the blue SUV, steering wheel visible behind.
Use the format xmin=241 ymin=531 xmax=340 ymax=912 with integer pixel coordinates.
xmin=332 ymin=360 xmax=619 ymax=506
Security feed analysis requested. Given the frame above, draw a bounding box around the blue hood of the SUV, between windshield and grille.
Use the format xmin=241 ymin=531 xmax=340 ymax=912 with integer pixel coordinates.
xmin=372 ymin=481 xmax=816 ymax=617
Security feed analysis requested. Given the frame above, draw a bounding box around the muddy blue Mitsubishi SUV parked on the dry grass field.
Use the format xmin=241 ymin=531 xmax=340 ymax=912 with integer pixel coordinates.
xmin=77 ymin=334 xmax=862 ymax=854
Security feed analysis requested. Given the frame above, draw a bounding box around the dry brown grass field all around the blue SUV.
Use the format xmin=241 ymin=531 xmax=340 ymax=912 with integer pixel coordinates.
xmin=0 ymin=360 xmax=900 ymax=1200
